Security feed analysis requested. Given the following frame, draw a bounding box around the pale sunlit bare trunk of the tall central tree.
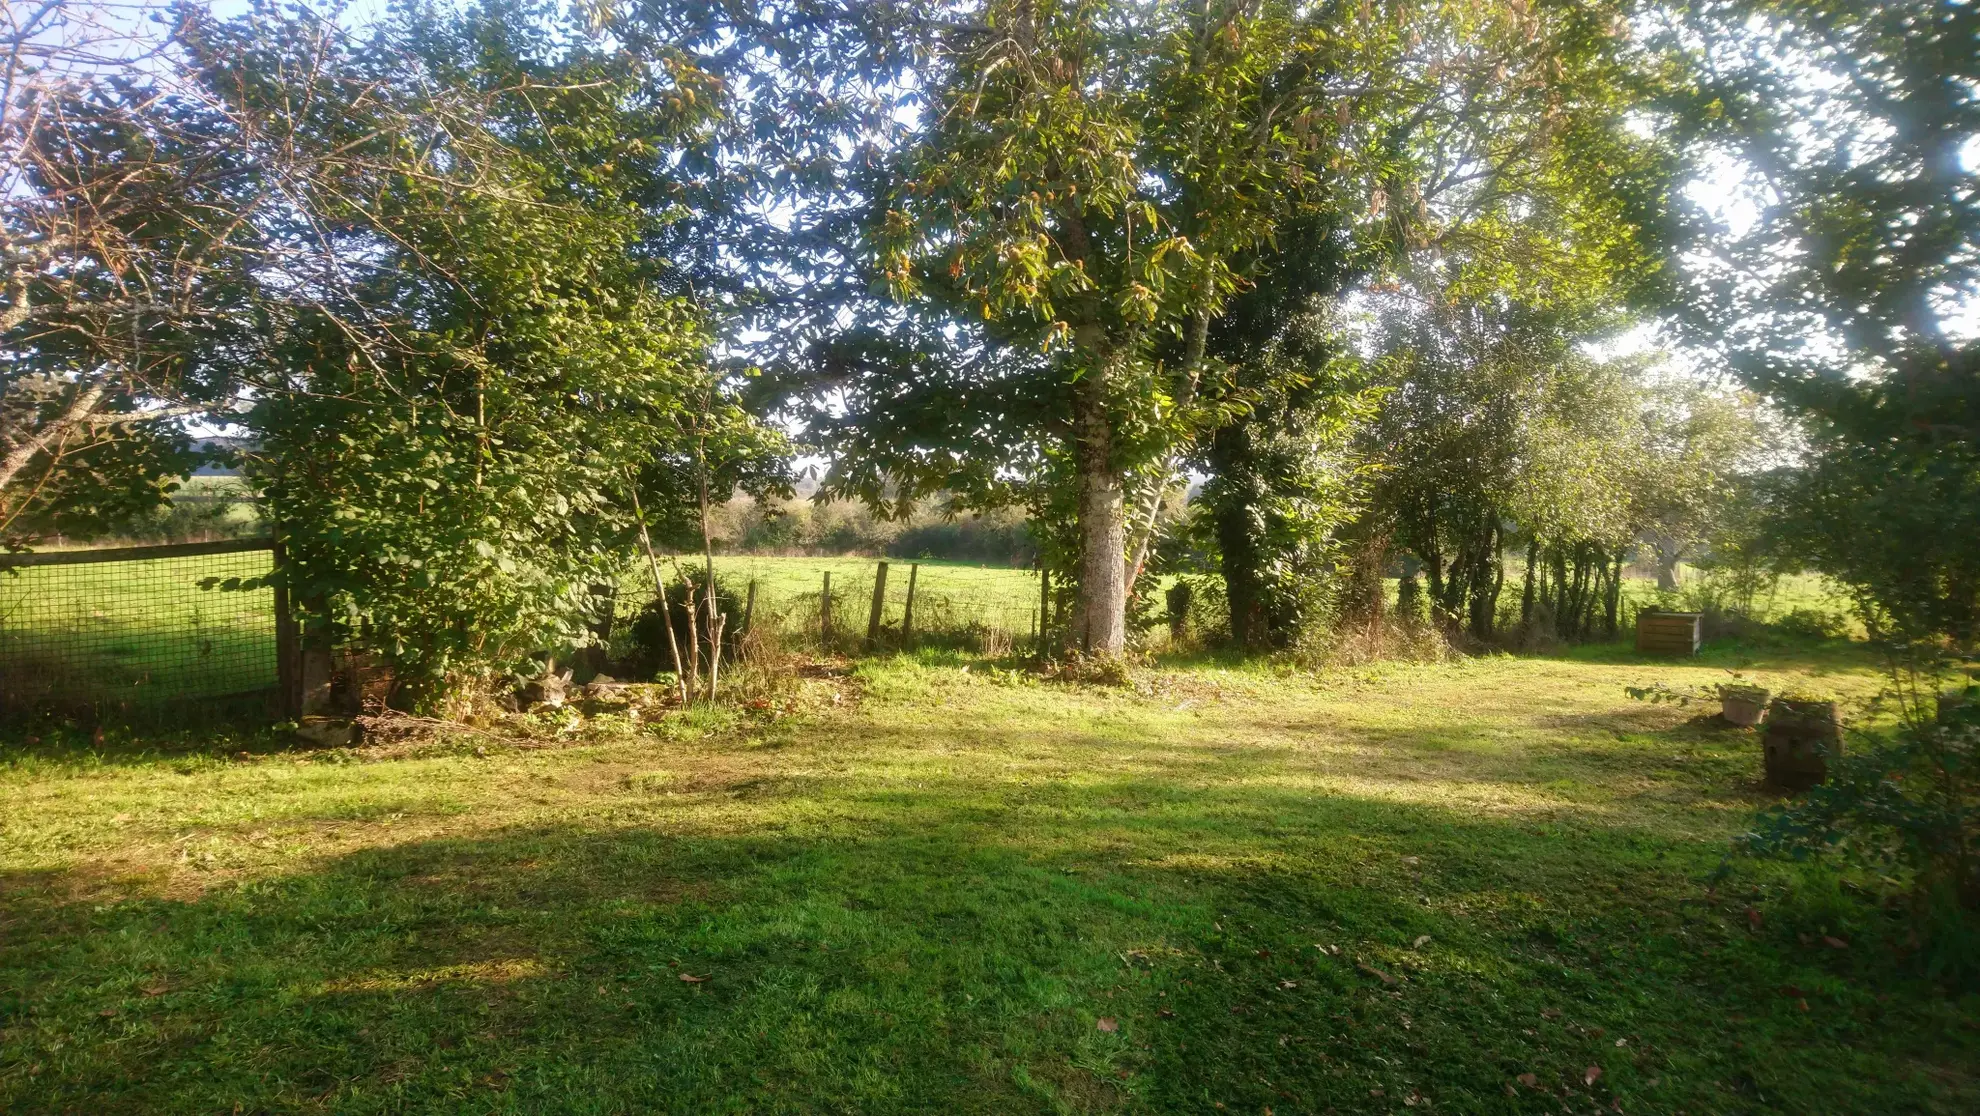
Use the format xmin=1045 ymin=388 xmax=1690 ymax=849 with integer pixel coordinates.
xmin=1069 ymin=358 xmax=1127 ymax=659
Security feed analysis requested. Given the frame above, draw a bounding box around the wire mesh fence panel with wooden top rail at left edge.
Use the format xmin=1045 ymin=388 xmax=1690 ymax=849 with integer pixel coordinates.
xmin=0 ymin=540 xmax=277 ymax=710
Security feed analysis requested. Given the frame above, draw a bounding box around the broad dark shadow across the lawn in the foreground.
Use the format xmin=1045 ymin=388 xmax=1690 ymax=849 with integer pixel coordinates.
xmin=0 ymin=778 xmax=1980 ymax=1112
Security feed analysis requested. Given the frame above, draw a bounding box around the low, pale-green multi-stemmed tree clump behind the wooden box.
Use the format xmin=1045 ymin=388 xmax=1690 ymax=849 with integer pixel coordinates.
xmin=1362 ymin=297 xmax=1726 ymax=643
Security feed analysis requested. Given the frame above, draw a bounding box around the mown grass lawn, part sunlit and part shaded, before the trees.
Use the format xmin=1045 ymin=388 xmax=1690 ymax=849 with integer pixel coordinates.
xmin=0 ymin=633 xmax=1980 ymax=1114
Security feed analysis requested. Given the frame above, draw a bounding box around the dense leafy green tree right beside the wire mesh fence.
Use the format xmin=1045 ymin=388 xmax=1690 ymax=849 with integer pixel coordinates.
xmin=184 ymin=6 xmax=750 ymax=704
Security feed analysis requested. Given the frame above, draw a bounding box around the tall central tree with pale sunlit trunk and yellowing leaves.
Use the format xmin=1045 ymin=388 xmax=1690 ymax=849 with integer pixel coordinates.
xmin=875 ymin=0 xmax=1441 ymax=657
